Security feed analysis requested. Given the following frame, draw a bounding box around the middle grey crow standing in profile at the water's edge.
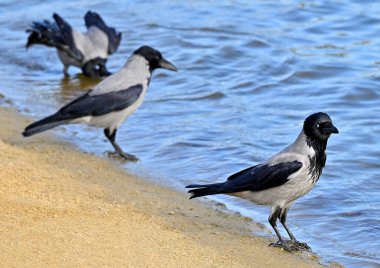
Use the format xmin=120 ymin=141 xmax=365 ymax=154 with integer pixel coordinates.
xmin=23 ymin=46 xmax=177 ymax=161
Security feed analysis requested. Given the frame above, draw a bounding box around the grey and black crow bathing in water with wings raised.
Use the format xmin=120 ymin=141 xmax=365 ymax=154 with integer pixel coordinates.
xmin=26 ymin=11 xmax=121 ymax=77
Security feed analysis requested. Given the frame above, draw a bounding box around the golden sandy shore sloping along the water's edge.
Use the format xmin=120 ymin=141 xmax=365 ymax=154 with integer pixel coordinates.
xmin=0 ymin=108 xmax=318 ymax=268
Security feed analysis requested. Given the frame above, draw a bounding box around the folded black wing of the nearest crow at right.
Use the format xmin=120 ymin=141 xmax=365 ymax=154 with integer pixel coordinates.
xmin=220 ymin=161 xmax=302 ymax=193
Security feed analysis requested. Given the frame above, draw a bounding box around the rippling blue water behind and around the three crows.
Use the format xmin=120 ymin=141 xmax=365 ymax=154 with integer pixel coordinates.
xmin=0 ymin=0 xmax=380 ymax=267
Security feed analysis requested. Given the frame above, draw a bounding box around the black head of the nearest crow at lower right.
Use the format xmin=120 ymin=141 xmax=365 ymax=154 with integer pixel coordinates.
xmin=303 ymin=113 xmax=339 ymax=141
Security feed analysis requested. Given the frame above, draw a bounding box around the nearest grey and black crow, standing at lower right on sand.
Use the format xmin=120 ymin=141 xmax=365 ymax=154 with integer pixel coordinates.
xmin=186 ymin=113 xmax=339 ymax=251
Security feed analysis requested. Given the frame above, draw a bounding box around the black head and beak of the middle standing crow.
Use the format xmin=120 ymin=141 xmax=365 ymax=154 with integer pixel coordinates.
xmin=133 ymin=46 xmax=177 ymax=72
